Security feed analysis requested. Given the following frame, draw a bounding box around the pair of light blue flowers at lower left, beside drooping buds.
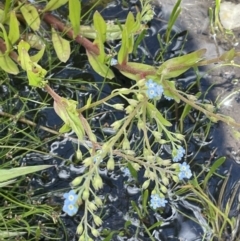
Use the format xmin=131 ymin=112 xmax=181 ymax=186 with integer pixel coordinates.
xmin=63 ymin=190 xmax=78 ymax=216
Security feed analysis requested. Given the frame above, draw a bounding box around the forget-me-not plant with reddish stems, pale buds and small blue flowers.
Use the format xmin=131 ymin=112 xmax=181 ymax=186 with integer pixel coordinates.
xmin=0 ymin=0 xmax=240 ymax=241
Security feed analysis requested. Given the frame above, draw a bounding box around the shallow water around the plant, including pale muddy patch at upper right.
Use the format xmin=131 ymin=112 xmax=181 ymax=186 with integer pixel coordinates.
xmin=0 ymin=0 xmax=240 ymax=241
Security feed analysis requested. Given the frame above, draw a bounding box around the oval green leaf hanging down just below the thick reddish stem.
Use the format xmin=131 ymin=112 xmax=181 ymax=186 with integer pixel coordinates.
xmin=52 ymin=28 xmax=71 ymax=63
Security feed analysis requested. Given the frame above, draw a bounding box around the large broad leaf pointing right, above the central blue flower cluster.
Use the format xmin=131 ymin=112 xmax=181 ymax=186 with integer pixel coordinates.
xmin=157 ymin=49 xmax=206 ymax=79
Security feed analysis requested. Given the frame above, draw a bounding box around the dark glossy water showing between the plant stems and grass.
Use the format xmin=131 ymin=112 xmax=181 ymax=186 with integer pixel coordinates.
xmin=0 ymin=1 xmax=239 ymax=241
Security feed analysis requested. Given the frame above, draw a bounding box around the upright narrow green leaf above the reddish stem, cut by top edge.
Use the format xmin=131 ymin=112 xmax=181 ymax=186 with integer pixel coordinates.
xmin=68 ymin=0 xmax=81 ymax=37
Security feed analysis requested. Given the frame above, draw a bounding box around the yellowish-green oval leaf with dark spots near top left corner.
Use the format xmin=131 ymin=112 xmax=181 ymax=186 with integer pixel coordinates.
xmin=18 ymin=2 xmax=41 ymax=31
